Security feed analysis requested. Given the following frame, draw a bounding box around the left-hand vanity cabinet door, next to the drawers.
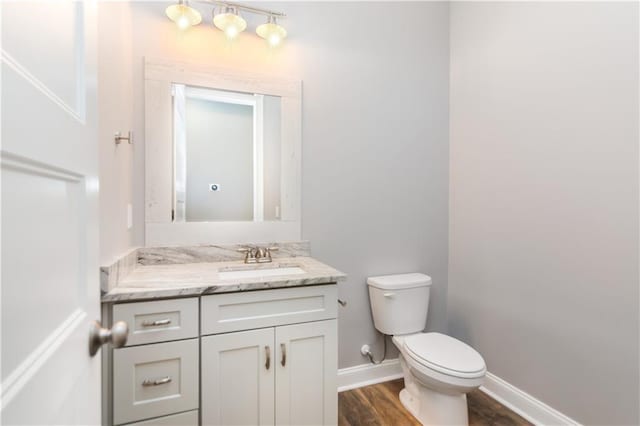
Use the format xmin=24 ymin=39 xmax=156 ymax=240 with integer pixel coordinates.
xmin=201 ymin=328 xmax=275 ymax=426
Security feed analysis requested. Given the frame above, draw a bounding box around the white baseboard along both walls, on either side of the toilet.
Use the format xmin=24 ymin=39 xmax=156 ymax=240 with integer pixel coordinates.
xmin=338 ymin=359 xmax=580 ymax=426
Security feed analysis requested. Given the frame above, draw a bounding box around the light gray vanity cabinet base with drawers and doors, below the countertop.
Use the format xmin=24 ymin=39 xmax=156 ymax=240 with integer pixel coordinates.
xmin=106 ymin=284 xmax=338 ymax=426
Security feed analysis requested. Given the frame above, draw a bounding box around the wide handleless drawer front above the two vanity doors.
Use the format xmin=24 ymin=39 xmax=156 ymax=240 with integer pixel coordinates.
xmin=200 ymin=284 xmax=338 ymax=335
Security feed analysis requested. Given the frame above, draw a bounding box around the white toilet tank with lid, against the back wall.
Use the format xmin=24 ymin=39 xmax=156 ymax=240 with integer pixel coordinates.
xmin=367 ymin=273 xmax=431 ymax=335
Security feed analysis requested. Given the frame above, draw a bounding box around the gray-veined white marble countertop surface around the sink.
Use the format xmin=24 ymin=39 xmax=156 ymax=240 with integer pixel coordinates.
xmin=102 ymin=257 xmax=346 ymax=303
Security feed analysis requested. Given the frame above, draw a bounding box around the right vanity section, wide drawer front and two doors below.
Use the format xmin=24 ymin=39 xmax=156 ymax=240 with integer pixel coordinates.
xmin=201 ymin=285 xmax=338 ymax=426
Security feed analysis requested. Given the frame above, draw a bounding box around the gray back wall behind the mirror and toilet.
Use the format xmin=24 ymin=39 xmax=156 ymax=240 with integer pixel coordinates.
xmin=126 ymin=2 xmax=449 ymax=368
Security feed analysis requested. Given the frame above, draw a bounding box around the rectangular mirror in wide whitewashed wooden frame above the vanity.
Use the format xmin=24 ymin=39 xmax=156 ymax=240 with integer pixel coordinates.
xmin=145 ymin=60 xmax=301 ymax=245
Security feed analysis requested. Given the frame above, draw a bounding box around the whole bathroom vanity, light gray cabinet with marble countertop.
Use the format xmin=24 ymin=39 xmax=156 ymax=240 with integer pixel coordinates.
xmin=103 ymin=243 xmax=345 ymax=425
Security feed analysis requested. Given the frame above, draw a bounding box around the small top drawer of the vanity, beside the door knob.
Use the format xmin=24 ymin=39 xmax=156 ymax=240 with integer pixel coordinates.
xmin=113 ymin=298 xmax=198 ymax=346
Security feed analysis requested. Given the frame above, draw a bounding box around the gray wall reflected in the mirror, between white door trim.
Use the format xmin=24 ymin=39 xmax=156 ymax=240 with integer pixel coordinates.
xmin=185 ymin=97 xmax=253 ymax=222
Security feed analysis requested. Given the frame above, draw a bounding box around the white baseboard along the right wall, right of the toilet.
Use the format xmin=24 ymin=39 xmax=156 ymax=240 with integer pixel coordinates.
xmin=480 ymin=372 xmax=580 ymax=426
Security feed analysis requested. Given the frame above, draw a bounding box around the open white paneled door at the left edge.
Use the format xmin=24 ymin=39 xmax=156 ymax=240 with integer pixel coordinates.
xmin=0 ymin=1 xmax=100 ymax=425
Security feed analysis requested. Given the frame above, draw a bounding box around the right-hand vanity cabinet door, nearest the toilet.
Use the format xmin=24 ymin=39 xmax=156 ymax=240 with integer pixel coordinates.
xmin=275 ymin=320 xmax=338 ymax=425
